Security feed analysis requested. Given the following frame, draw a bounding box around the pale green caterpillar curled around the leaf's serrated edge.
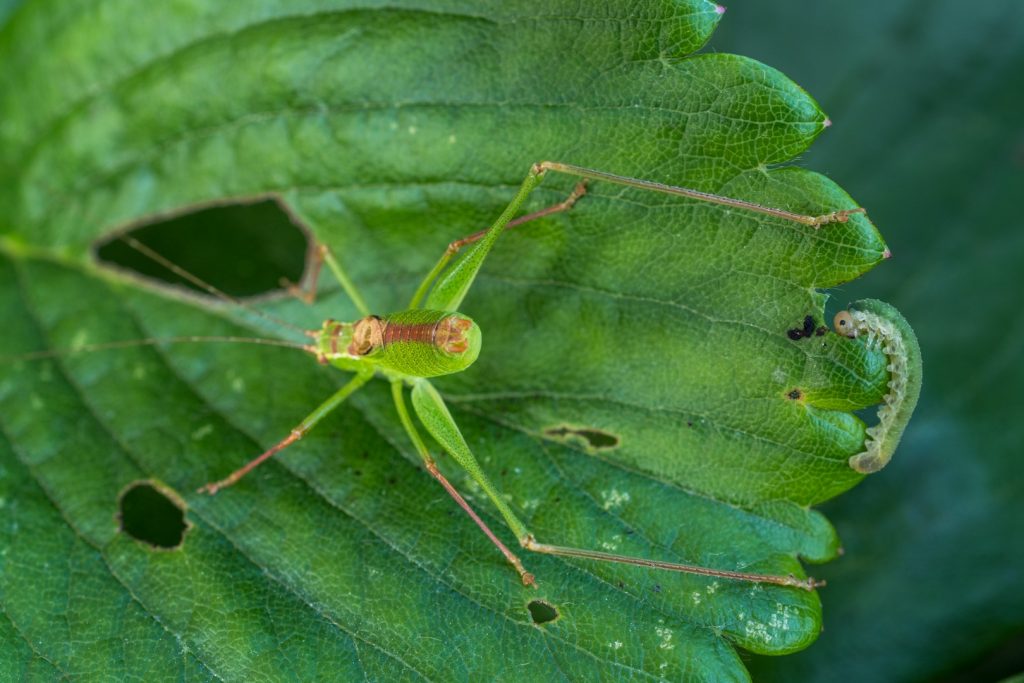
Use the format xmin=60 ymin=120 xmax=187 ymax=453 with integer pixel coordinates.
xmin=835 ymin=299 xmax=923 ymax=473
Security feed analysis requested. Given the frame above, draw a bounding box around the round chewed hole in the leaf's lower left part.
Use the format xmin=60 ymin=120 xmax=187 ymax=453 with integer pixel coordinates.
xmin=118 ymin=481 xmax=189 ymax=550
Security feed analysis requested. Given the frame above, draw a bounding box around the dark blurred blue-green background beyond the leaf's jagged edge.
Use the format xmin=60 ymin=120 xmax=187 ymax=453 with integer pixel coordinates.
xmin=707 ymin=0 xmax=1024 ymax=682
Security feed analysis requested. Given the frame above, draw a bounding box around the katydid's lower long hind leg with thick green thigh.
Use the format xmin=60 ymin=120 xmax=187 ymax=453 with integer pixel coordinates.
xmin=413 ymin=380 xmax=824 ymax=591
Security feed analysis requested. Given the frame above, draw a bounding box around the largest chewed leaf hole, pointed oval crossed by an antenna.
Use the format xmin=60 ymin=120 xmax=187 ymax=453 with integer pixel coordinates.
xmin=93 ymin=194 xmax=309 ymax=298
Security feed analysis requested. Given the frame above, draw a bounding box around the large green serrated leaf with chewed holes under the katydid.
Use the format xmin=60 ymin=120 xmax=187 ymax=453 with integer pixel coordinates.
xmin=0 ymin=0 xmax=899 ymax=681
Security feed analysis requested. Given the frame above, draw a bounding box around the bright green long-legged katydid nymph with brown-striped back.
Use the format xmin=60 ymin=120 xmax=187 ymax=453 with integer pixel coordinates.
xmin=22 ymin=162 xmax=880 ymax=591
